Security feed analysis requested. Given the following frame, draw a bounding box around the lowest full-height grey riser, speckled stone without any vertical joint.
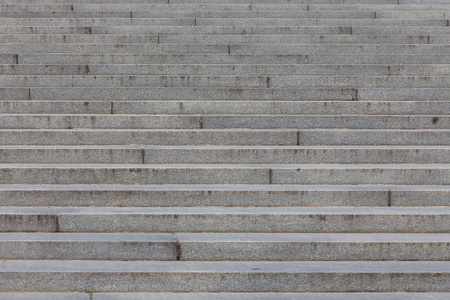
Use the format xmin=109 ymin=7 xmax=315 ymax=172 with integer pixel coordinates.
xmin=0 ymin=264 xmax=450 ymax=292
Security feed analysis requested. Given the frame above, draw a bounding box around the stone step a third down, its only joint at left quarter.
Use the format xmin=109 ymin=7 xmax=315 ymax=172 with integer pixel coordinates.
xmin=0 ymin=100 xmax=450 ymax=115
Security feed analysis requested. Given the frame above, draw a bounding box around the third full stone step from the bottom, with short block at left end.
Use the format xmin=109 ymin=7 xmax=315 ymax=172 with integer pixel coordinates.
xmin=0 ymin=206 xmax=450 ymax=233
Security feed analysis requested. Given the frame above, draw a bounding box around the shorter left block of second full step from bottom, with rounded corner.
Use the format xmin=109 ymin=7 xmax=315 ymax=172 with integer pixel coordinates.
xmin=0 ymin=233 xmax=178 ymax=262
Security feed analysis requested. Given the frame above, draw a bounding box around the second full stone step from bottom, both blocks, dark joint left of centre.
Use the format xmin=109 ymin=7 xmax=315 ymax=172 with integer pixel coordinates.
xmin=0 ymin=233 xmax=450 ymax=260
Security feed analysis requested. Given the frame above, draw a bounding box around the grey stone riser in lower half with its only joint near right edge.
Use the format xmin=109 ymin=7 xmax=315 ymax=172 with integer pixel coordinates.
xmin=0 ymin=185 xmax=450 ymax=207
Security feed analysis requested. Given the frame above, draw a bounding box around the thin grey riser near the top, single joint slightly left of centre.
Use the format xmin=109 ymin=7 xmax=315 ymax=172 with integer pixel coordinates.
xmin=0 ymin=18 xmax=448 ymax=30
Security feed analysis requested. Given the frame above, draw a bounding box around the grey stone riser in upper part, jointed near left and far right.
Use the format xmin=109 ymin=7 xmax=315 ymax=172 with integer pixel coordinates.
xmin=0 ymin=64 xmax=450 ymax=77
